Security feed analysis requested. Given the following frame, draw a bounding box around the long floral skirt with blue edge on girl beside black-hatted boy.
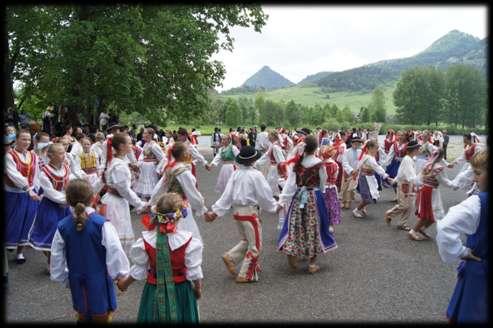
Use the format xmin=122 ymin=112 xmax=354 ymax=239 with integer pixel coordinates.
xmin=277 ymin=188 xmax=337 ymax=258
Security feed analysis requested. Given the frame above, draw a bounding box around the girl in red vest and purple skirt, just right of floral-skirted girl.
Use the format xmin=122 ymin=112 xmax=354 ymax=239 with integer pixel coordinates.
xmin=320 ymin=146 xmax=341 ymax=233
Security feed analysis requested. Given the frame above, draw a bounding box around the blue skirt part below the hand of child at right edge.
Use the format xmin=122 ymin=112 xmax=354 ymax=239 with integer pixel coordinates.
xmin=447 ymin=260 xmax=488 ymax=323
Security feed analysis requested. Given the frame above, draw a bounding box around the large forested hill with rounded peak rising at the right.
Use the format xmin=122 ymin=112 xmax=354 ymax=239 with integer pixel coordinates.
xmin=315 ymin=30 xmax=487 ymax=91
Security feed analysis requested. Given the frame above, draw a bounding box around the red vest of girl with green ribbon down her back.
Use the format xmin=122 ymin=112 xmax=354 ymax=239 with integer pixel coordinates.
xmin=144 ymin=237 xmax=192 ymax=285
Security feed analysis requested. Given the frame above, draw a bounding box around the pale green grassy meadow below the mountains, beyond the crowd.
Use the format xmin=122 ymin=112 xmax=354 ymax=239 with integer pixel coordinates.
xmin=219 ymin=83 xmax=395 ymax=115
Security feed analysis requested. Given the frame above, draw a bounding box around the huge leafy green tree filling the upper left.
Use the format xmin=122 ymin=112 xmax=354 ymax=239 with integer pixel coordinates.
xmin=4 ymin=5 xmax=267 ymax=128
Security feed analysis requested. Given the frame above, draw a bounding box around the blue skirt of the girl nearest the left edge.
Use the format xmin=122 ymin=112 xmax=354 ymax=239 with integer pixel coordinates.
xmin=4 ymin=191 xmax=39 ymax=248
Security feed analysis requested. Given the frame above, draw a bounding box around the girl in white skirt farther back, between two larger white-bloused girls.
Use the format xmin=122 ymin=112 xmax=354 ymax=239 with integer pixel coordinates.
xmin=133 ymin=128 xmax=165 ymax=199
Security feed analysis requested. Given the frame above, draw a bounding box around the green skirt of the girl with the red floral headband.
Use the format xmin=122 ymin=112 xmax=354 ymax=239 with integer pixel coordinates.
xmin=137 ymin=281 xmax=199 ymax=323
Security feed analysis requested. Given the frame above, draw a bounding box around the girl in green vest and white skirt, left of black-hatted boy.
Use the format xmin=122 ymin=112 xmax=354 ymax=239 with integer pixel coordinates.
xmin=207 ymin=136 xmax=240 ymax=194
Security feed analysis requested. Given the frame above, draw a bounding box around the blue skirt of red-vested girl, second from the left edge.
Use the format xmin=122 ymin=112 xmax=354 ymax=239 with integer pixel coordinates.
xmin=29 ymin=198 xmax=70 ymax=251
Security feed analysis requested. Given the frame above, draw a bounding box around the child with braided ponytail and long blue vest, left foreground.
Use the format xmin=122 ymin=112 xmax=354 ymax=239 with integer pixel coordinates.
xmin=50 ymin=179 xmax=130 ymax=323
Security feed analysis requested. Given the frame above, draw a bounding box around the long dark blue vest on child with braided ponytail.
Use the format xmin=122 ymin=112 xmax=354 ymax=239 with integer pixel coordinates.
xmin=58 ymin=213 xmax=116 ymax=316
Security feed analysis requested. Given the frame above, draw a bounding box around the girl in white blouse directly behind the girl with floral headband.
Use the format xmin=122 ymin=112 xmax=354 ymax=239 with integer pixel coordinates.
xmin=149 ymin=141 xmax=207 ymax=240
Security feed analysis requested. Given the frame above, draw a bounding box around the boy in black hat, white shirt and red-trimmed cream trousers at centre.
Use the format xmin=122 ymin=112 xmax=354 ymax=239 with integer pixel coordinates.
xmin=206 ymin=146 xmax=280 ymax=283
